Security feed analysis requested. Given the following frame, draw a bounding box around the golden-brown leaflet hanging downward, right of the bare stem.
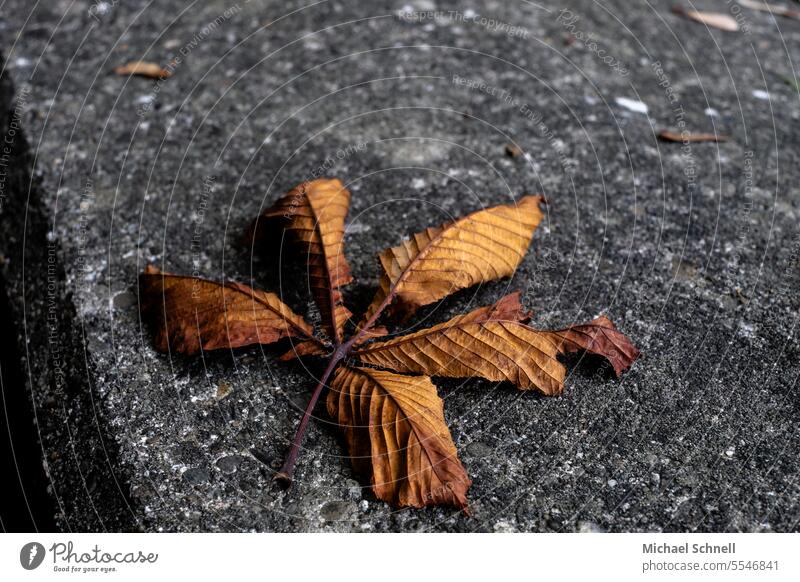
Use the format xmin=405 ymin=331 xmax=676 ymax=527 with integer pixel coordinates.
xmin=328 ymin=367 xmax=471 ymax=509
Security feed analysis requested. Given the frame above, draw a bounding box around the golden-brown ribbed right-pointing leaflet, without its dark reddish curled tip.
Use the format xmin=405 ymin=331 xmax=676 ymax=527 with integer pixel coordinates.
xmin=354 ymin=293 xmax=565 ymax=395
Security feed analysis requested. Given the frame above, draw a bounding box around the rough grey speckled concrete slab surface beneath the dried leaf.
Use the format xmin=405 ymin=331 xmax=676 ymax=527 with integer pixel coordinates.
xmin=0 ymin=0 xmax=800 ymax=531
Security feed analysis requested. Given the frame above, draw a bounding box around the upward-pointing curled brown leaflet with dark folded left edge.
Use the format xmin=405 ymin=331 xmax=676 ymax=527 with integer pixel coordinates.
xmin=248 ymin=178 xmax=353 ymax=344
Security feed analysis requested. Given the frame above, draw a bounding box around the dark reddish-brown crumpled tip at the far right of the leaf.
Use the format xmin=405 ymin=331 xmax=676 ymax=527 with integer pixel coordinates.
xmin=551 ymin=315 xmax=640 ymax=377
